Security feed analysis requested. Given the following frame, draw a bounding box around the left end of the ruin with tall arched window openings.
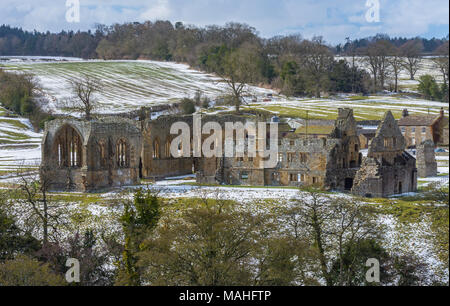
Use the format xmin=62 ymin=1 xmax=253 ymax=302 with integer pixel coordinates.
xmin=41 ymin=118 xmax=141 ymax=191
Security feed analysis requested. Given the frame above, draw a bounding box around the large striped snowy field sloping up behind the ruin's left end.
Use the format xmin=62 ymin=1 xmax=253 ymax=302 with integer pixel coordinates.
xmin=0 ymin=58 xmax=272 ymax=113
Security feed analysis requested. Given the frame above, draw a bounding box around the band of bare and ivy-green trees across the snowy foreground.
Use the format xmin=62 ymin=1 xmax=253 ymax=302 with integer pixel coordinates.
xmin=0 ymin=169 xmax=448 ymax=286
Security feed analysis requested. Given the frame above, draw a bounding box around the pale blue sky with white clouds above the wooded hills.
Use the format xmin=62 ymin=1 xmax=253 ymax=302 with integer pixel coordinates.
xmin=0 ymin=0 xmax=449 ymax=44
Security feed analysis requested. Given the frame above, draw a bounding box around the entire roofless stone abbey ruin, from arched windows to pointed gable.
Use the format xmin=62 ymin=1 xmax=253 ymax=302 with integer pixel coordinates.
xmin=41 ymin=109 xmax=420 ymax=197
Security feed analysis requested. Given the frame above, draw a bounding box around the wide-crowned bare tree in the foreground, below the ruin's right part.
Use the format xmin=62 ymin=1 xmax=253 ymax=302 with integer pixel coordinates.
xmin=285 ymin=189 xmax=381 ymax=286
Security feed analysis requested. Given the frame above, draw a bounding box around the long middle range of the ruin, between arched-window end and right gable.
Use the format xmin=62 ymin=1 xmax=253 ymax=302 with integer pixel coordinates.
xmin=142 ymin=110 xmax=361 ymax=190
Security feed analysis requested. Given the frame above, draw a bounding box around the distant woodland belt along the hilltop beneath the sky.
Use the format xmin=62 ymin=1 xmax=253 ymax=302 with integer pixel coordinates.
xmin=0 ymin=21 xmax=448 ymax=101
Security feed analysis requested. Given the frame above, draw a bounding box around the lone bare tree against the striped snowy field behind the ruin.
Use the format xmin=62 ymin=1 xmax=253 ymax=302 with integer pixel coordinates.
xmin=66 ymin=74 xmax=103 ymax=120
